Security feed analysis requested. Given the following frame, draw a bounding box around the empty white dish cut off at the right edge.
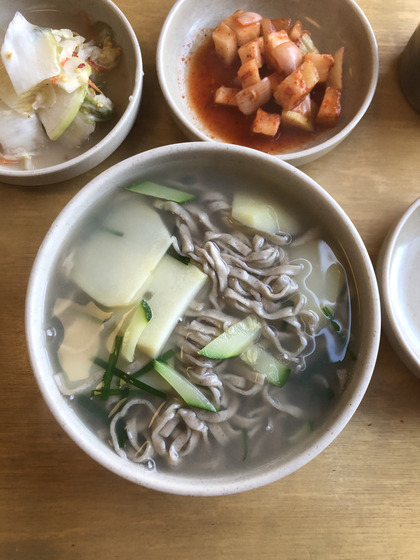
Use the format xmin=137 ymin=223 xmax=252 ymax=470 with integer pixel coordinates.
xmin=376 ymin=198 xmax=420 ymax=377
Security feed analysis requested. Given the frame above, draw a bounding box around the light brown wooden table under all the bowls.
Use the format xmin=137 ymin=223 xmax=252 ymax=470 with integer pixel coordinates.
xmin=0 ymin=0 xmax=420 ymax=560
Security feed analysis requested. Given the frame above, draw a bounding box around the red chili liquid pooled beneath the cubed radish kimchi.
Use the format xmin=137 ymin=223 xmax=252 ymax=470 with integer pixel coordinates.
xmin=186 ymin=34 xmax=323 ymax=154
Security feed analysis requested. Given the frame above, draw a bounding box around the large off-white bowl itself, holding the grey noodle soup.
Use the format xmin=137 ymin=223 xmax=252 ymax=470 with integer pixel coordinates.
xmin=26 ymin=142 xmax=380 ymax=495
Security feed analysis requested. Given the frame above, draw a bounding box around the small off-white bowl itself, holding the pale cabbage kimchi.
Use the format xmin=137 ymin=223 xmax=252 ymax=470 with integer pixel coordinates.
xmin=0 ymin=0 xmax=143 ymax=185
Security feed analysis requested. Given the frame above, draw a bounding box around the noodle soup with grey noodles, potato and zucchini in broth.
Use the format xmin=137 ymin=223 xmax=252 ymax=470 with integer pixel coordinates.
xmin=44 ymin=156 xmax=359 ymax=476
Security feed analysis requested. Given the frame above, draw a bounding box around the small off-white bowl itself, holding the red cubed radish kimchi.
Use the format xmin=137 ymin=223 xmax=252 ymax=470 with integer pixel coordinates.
xmin=156 ymin=0 xmax=379 ymax=166
